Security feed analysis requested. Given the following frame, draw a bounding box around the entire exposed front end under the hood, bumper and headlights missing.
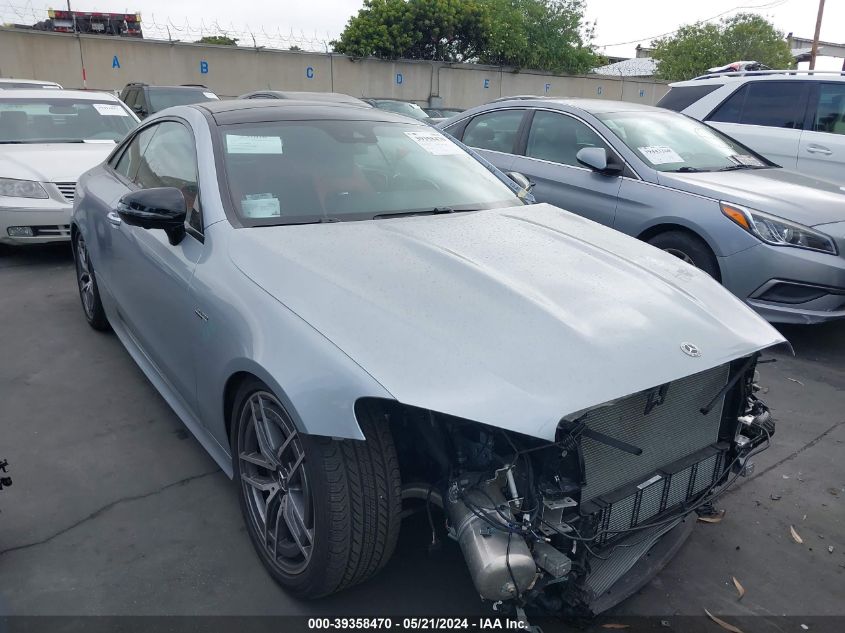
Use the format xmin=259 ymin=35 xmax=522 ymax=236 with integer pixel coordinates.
xmin=387 ymin=354 xmax=774 ymax=617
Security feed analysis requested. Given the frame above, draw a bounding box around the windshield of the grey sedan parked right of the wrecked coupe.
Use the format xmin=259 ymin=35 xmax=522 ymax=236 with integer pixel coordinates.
xmin=596 ymin=112 xmax=772 ymax=172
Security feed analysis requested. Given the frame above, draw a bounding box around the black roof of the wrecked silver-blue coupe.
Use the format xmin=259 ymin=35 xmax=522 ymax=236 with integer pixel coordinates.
xmin=195 ymin=99 xmax=425 ymax=125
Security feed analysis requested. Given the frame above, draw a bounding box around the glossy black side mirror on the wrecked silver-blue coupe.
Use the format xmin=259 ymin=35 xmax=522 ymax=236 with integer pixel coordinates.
xmin=117 ymin=187 xmax=188 ymax=246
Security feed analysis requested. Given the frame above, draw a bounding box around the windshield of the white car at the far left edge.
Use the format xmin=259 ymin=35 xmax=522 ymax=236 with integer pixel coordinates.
xmin=0 ymin=97 xmax=138 ymax=143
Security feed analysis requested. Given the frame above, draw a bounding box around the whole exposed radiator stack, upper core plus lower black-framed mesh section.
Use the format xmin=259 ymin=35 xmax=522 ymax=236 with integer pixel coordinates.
xmin=581 ymin=365 xmax=730 ymax=545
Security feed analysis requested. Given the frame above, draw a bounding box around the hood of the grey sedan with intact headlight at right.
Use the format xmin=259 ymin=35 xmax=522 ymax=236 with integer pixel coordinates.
xmin=658 ymin=168 xmax=845 ymax=226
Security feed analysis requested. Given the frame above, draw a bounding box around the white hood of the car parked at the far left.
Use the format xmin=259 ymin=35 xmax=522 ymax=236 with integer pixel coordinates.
xmin=0 ymin=143 xmax=114 ymax=182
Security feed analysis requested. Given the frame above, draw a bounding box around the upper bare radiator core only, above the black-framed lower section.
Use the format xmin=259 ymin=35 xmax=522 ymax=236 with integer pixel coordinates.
xmin=581 ymin=365 xmax=730 ymax=503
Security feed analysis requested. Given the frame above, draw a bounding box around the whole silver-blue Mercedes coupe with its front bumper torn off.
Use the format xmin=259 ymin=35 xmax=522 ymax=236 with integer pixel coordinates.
xmin=72 ymin=100 xmax=783 ymax=614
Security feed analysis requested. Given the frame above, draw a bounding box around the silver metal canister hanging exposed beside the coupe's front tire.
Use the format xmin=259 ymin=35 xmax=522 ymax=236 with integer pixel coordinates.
xmin=445 ymin=481 xmax=537 ymax=601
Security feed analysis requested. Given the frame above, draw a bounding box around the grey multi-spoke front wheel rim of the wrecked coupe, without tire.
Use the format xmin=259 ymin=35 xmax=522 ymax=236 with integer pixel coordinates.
xmin=237 ymin=391 xmax=314 ymax=574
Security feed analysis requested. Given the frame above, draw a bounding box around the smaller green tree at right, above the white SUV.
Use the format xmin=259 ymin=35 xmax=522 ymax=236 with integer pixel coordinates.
xmin=652 ymin=13 xmax=795 ymax=81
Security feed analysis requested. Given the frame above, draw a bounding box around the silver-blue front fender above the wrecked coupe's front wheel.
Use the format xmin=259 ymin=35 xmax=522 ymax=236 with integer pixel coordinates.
xmin=192 ymin=223 xmax=393 ymax=454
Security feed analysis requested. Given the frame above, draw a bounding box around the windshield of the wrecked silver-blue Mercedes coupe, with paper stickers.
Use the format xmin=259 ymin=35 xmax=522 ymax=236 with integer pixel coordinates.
xmin=221 ymin=120 xmax=522 ymax=226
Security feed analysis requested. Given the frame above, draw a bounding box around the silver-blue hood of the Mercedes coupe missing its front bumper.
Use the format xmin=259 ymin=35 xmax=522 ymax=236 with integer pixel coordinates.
xmin=229 ymin=204 xmax=783 ymax=440
